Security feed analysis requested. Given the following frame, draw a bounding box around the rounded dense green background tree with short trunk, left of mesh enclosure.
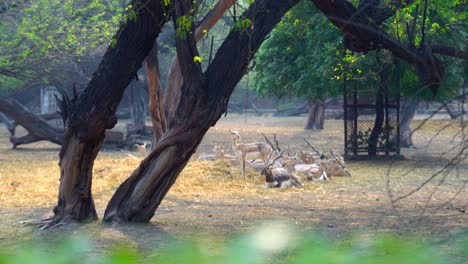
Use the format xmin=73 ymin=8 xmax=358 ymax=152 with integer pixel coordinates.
xmin=254 ymin=1 xmax=342 ymax=130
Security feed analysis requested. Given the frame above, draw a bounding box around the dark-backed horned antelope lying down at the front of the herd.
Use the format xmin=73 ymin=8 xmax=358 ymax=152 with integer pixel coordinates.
xmin=260 ymin=155 xmax=304 ymax=189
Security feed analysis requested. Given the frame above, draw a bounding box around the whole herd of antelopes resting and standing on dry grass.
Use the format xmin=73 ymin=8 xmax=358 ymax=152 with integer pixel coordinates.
xmin=198 ymin=130 xmax=351 ymax=188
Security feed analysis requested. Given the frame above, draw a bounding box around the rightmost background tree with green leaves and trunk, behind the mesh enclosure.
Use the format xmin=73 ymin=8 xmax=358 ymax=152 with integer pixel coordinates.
xmin=386 ymin=0 xmax=468 ymax=147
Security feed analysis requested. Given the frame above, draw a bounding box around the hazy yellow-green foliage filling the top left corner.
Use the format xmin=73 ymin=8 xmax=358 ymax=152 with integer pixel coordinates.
xmin=0 ymin=0 xmax=123 ymax=89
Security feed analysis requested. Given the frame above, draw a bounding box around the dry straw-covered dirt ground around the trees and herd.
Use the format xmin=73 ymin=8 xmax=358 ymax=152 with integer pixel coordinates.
xmin=0 ymin=115 xmax=468 ymax=255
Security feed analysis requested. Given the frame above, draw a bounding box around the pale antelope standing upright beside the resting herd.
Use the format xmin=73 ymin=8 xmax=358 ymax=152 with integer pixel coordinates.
xmin=229 ymin=130 xmax=272 ymax=180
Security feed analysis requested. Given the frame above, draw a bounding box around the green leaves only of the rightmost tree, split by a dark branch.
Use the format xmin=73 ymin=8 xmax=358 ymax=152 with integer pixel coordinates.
xmin=385 ymin=0 xmax=468 ymax=101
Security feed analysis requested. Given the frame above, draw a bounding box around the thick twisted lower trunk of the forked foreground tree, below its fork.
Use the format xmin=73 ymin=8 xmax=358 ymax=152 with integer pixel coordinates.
xmin=104 ymin=122 xmax=209 ymax=222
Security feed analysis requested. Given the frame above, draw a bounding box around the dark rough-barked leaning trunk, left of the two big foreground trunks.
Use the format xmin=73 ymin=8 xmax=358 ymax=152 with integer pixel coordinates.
xmin=49 ymin=0 xmax=167 ymax=225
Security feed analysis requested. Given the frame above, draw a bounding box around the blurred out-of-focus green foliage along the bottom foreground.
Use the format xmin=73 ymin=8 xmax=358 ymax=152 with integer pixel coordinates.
xmin=0 ymin=228 xmax=468 ymax=264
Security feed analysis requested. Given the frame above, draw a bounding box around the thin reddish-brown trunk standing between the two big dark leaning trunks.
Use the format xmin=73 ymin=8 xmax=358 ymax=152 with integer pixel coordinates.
xmin=145 ymin=43 xmax=166 ymax=146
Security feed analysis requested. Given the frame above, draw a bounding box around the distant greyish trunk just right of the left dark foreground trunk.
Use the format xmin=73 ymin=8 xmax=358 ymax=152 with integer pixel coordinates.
xmin=127 ymin=83 xmax=147 ymax=135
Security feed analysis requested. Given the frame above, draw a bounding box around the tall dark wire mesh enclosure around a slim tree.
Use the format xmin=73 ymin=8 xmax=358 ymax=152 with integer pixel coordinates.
xmin=343 ymin=82 xmax=400 ymax=158
